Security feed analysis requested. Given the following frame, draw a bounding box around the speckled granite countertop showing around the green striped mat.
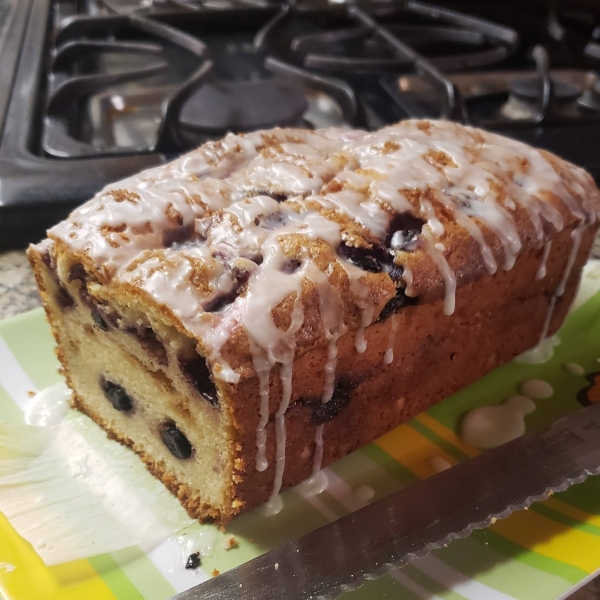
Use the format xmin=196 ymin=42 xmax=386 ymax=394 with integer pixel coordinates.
xmin=0 ymin=241 xmax=600 ymax=600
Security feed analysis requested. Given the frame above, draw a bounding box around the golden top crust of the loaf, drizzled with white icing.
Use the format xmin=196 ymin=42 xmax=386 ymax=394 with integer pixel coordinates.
xmin=49 ymin=120 xmax=600 ymax=384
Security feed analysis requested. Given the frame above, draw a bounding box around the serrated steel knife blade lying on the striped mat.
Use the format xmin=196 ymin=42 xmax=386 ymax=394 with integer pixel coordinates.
xmin=172 ymin=403 xmax=600 ymax=600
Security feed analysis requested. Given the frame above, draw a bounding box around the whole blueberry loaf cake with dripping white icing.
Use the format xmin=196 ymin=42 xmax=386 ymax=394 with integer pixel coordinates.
xmin=29 ymin=120 xmax=600 ymax=523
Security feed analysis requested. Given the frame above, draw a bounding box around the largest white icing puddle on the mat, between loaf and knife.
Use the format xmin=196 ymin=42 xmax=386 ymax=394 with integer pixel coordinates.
xmin=460 ymin=396 xmax=535 ymax=448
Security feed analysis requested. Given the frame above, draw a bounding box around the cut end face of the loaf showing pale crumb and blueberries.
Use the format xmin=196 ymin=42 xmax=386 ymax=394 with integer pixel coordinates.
xmin=29 ymin=247 xmax=242 ymax=523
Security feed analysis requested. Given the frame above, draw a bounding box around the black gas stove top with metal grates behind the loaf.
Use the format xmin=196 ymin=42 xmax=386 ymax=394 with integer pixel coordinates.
xmin=0 ymin=0 xmax=600 ymax=248
